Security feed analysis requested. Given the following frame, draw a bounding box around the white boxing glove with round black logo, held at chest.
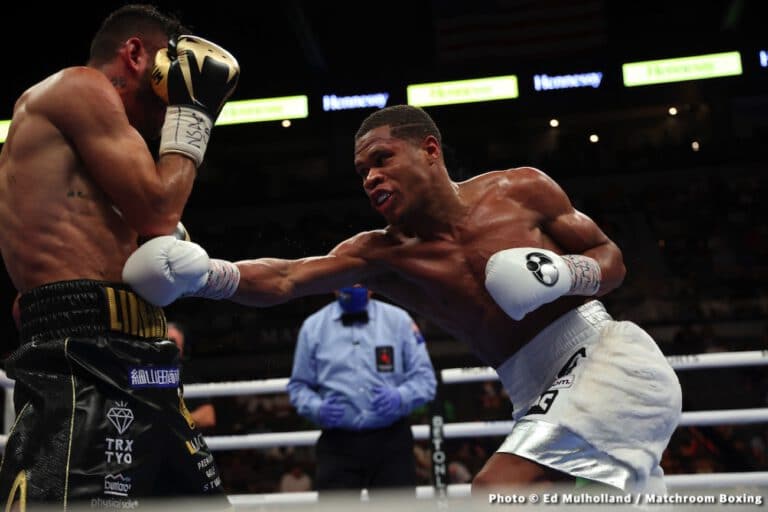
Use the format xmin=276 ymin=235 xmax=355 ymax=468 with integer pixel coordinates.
xmin=485 ymin=247 xmax=600 ymax=320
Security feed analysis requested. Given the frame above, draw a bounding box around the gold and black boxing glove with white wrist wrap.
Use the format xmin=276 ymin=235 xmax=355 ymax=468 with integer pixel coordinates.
xmin=152 ymin=35 xmax=240 ymax=167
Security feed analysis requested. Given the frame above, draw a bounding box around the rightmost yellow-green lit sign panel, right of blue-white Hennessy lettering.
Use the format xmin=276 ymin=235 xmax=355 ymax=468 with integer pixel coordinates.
xmin=622 ymin=52 xmax=742 ymax=87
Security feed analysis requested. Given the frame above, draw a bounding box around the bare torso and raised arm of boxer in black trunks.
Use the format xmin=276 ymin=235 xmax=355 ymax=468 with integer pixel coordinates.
xmin=0 ymin=67 xmax=195 ymax=293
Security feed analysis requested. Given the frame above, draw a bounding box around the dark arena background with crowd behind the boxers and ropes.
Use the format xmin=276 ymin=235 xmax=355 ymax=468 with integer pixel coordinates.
xmin=0 ymin=0 xmax=768 ymax=492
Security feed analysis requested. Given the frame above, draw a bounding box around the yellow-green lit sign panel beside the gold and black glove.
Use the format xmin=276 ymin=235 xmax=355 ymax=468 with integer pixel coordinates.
xmin=216 ymin=95 xmax=309 ymax=126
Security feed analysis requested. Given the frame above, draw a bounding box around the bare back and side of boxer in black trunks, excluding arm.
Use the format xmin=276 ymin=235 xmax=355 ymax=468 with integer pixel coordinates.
xmin=0 ymin=71 xmax=136 ymax=292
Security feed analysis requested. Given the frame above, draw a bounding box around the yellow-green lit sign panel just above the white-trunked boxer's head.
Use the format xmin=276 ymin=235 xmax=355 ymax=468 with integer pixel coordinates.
xmin=407 ymin=75 xmax=518 ymax=107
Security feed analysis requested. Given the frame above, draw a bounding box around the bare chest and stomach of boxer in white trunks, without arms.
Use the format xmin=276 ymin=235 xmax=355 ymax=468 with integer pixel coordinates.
xmin=342 ymin=170 xmax=585 ymax=366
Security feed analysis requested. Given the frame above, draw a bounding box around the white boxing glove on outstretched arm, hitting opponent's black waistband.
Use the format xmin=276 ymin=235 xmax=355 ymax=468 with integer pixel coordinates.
xmin=123 ymin=236 xmax=240 ymax=306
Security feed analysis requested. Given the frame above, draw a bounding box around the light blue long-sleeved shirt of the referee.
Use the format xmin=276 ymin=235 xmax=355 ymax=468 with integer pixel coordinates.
xmin=288 ymin=299 xmax=437 ymax=430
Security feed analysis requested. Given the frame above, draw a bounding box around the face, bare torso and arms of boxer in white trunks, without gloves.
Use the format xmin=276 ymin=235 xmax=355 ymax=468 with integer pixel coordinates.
xmin=233 ymin=126 xmax=624 ymax=366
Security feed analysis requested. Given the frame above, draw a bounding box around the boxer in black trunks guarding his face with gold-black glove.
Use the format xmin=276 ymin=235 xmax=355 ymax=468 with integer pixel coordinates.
xmin=0 ymin=5 xmax=239 ymax=510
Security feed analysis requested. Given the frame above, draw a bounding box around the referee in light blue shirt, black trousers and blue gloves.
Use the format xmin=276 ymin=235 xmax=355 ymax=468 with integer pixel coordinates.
xmin=288 ymin=286 xmax=437 ymax=491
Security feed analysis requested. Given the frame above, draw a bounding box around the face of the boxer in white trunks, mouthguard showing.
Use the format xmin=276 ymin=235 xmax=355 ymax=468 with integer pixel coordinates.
xmin=355 ymin=126 xmax=431 ymax=224
